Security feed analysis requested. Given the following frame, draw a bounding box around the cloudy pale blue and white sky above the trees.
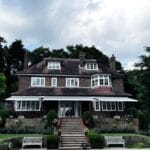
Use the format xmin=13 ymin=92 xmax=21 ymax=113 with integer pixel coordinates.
xmin=0 ymin=0 xmax=150 ymax=69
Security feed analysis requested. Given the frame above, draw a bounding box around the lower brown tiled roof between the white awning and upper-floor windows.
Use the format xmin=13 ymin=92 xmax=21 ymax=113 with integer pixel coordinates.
xmin=12 ymin=87 xmax=131 ymax=96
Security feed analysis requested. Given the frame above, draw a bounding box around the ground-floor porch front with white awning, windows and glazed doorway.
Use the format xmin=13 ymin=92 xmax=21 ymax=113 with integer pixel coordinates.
xmin=6 ymin=96 xmax=137 ymax=117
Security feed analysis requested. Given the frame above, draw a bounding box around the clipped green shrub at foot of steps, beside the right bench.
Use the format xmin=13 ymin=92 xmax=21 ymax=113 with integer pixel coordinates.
xmin=88 ymin=132 xmax=105 ymax=148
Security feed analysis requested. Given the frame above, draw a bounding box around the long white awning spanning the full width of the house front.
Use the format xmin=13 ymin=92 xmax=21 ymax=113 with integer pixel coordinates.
xmin=6 ymin=96 xmax=138 ymax=102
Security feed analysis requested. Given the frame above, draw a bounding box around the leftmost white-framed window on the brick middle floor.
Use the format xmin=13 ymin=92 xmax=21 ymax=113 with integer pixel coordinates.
xmin=31 ymin=77 xmax=45 ymax=87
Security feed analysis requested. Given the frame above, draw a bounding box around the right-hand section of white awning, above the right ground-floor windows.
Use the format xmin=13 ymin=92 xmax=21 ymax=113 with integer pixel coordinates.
xmin=94 ymin=97 xmax=138 ymax=102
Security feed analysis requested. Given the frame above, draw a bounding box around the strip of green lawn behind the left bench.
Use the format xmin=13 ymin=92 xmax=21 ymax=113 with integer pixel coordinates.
xmin=0 ymin=134 xmax=42 ymax=142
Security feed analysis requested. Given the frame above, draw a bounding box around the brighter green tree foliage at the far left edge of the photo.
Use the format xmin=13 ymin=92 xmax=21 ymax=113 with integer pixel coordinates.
xmin=0 ymin=73 xmax=6 ymax=96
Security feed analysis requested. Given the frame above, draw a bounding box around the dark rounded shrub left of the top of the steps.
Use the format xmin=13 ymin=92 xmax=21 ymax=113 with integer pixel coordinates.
xmin=47 ymin=110 xmax=57 ymax=127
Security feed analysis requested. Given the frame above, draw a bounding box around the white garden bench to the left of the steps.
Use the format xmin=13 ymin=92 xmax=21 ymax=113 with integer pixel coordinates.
xmin=22 ymin=137 xmax=43 ymax=148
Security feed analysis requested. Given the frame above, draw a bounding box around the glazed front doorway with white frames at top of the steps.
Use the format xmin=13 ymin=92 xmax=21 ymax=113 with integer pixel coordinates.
xmin=58 ymin=101 xmax=80 ymax=117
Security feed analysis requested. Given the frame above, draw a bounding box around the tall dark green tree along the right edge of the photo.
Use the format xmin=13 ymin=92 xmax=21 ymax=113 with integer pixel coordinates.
xmin=127 ymin=47 xmax=150 ymax=129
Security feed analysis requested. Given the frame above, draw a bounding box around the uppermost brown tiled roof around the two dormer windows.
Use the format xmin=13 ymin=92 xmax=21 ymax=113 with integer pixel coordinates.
xmin=18 ymin=58 xmax=122 ymax=76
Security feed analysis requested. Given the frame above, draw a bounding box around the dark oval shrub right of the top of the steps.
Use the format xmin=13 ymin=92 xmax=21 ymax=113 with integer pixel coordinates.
xmin=82 ymin=111 xmax=95 ymax=128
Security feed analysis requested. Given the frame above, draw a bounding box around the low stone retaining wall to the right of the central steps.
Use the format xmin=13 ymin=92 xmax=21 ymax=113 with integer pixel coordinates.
xmin=95 ymin=118 xmax=139 ymax=131
